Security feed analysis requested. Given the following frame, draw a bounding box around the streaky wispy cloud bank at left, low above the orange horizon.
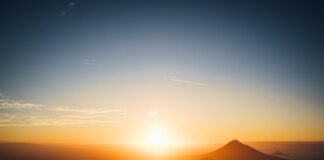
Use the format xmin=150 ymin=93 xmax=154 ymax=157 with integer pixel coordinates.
xmin=0 ymin=93 xmax=127 ymax=126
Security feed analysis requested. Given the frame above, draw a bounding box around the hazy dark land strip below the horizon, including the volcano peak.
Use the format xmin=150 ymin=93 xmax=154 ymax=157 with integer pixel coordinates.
xmin=0 ymin=140 xmax=324 ymax=160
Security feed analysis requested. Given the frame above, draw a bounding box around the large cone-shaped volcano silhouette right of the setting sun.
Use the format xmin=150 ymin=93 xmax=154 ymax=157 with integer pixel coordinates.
xmin=203 ymin=140 xmax=286 ymax=160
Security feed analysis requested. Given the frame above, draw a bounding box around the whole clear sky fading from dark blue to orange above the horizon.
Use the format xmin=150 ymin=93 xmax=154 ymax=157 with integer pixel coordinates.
xmin=0 ymin=0 xmax=324 ymax=144
